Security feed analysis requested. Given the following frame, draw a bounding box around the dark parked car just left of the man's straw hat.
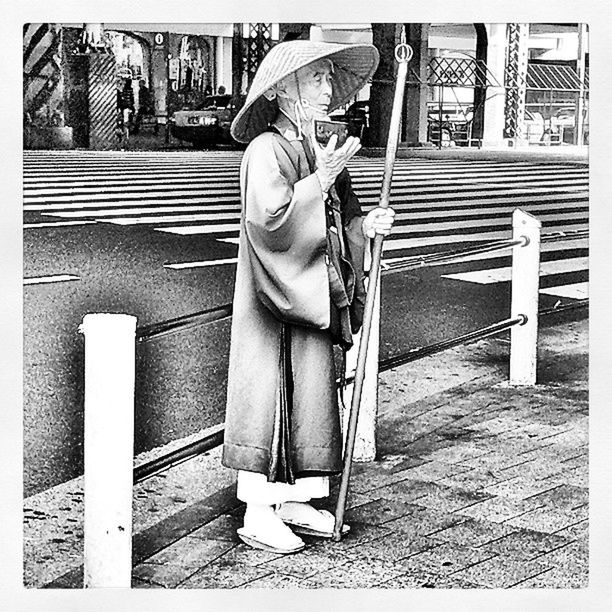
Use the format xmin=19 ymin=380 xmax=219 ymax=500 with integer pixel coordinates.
xmin=170 ymin=94 xmax=245 ymax=147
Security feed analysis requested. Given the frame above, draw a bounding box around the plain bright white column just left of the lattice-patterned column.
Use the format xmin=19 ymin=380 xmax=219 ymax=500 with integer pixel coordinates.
xmin=482 ymin=23 xmax=506 ymax=147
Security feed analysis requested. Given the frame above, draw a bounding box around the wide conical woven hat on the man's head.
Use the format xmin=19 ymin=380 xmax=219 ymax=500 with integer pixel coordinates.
xmin=231 ymin=40 xmax=379 ymax=143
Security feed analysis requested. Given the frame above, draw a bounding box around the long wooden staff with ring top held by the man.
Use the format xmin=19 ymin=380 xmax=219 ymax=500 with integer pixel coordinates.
xmin=332 ymin=30 xmax=412 ymax=542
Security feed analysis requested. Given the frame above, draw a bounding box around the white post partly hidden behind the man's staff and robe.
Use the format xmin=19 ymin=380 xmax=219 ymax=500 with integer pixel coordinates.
xmin=342 ymin=280 xmax=380 ymax=463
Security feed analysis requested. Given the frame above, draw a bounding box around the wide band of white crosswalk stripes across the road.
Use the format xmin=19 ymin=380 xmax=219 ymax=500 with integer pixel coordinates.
xmin=24 ymin=151 xmax=589 ymax=296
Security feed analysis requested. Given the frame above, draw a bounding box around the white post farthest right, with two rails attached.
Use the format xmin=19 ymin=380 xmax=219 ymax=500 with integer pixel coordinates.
xmin=510 ymin=208 xmax=542 ymax=385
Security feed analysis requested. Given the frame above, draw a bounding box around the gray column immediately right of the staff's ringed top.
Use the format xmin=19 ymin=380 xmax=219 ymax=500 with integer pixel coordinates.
xmin=400 ymin=23 xmax=429 ymax=147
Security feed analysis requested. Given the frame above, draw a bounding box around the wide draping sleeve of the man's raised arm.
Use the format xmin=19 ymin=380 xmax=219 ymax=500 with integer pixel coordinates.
xmin=241 ymin=134 xmax=330 ymax=329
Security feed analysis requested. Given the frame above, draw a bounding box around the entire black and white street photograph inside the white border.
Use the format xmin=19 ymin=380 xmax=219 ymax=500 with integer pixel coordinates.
xmin=6 ymin=3 xmax=609 ymax=610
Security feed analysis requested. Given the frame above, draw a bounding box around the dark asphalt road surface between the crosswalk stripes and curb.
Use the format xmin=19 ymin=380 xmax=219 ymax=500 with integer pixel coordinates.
xmin=24 ymin=149 xmax=588 ymax=495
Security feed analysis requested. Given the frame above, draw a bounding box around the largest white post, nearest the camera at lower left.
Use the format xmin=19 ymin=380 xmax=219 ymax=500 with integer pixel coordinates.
xmin=79 ymin=314 xmax=136 ymax=588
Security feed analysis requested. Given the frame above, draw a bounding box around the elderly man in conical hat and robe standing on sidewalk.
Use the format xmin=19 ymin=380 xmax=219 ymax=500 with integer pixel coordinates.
xmin=223 ymin=40 xmax=394 ymax=553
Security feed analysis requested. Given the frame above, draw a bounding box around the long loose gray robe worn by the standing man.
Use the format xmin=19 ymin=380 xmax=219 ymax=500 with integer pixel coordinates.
xmin=223 ymin=121 xmax=364 ymax=477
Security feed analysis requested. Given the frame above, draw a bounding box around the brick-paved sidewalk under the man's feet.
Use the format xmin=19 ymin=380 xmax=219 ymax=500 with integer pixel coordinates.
xmin=126 ymin=321 xmax=588 ymax=589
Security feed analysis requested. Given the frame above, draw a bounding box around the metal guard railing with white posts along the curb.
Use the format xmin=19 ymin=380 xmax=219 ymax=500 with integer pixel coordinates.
xmin=81 ymin=209 xmax=588 ymax=586
